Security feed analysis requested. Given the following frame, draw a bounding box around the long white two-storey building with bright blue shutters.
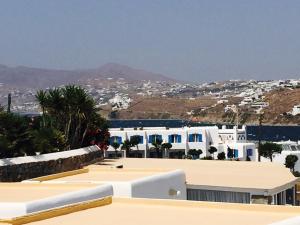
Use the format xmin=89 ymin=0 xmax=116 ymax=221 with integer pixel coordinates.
xmin=105 ymin=126 xmax=256 ymax=161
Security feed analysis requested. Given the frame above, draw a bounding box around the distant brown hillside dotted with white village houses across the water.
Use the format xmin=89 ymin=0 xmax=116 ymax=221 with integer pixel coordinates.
xmin=0 ymin=77 xmax=300 ymax=124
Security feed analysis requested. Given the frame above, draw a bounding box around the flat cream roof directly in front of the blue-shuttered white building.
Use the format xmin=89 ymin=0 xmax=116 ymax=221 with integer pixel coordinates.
xmin=99 ymin=158 xmax=298 ymax=190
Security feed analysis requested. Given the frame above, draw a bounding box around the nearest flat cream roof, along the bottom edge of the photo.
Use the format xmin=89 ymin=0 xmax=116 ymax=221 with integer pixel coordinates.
xmin=28 ymin=198 xmax=300 ymax=225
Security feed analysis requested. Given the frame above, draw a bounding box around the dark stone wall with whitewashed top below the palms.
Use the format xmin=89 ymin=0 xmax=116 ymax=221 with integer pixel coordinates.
xmin=0 ymin=146 xmax=103 ymax=182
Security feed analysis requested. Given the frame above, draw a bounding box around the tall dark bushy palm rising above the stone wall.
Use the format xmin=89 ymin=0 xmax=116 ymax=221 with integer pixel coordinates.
xmin=36 ymin=85 xmax=108 ymax=149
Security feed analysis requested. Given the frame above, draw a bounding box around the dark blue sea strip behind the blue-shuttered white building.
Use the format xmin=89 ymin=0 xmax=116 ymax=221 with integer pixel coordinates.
xmin=109 ymin=119 xmax=300 ymax=142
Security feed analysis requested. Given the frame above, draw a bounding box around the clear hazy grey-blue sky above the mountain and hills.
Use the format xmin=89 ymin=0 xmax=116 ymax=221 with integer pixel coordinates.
xmin=0 ymin=0 xmax=300 ymax=82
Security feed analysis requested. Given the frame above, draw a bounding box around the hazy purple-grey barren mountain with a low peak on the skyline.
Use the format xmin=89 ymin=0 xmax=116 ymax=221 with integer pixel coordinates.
xmin=0 ymin=63 xmax=173 ymax=88
